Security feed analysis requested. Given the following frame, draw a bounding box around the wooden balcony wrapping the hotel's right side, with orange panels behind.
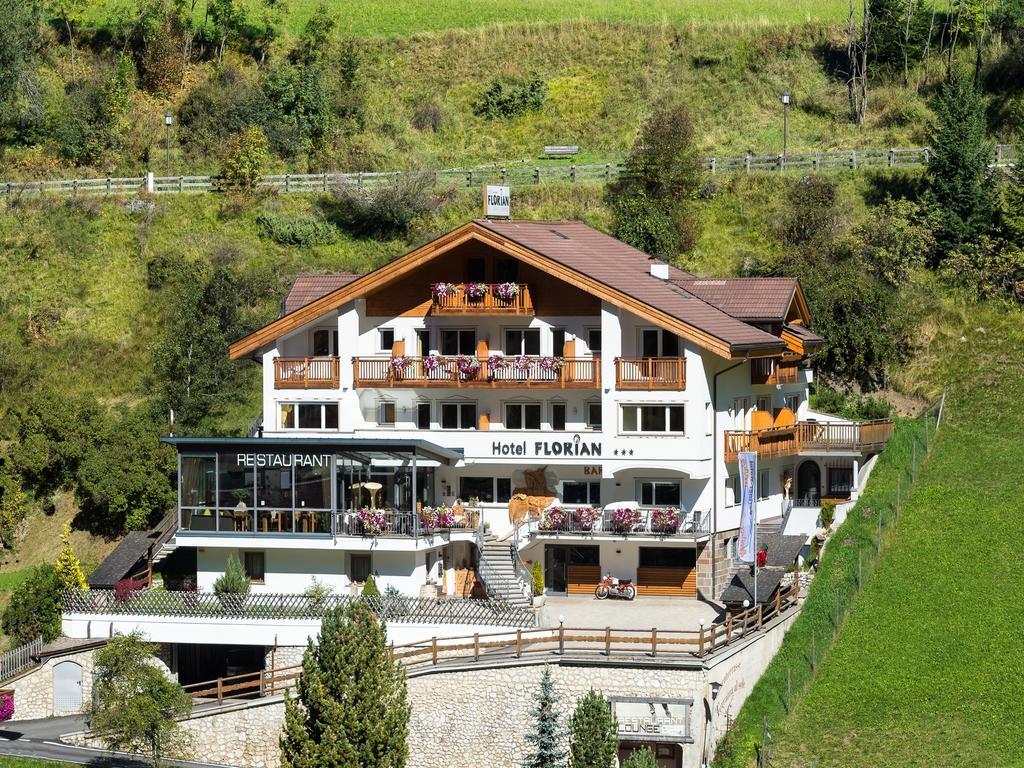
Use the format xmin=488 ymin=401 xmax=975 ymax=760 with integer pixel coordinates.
xmin=725 ymin=419 xmax=893 ymax=462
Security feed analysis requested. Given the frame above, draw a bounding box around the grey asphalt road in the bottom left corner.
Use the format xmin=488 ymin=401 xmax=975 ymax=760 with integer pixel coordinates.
xmin=0 ymin=715 xmax=232 ymax=768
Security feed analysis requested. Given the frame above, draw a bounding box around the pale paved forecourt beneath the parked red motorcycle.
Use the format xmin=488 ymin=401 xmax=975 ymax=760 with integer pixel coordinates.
xmin=539 ymin=595 xmax=723 ymax=630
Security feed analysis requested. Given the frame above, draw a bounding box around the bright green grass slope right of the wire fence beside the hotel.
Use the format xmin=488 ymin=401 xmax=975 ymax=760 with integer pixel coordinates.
xmin=773 ymin=307 xmax=1024 ymax=768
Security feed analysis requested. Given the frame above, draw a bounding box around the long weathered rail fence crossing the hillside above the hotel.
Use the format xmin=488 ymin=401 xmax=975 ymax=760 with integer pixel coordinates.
xmin=0 ymin=144 xmax=1024 ymax=197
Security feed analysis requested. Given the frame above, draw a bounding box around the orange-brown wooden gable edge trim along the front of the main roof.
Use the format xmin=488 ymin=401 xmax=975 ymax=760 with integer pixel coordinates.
xmin=228 ymin=221 xmax=786 ymax=359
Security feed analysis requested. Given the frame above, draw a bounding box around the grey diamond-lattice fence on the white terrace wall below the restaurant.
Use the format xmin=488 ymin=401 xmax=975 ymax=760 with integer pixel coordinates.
xmin=61 ymin=590 xmax=536 ymax=627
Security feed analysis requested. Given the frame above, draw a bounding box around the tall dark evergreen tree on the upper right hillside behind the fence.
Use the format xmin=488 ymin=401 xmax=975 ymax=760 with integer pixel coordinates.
xmin=927 ymin=73 xmax=994 ymax=259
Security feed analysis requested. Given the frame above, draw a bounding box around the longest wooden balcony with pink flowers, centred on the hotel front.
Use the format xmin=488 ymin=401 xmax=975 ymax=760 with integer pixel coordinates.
xmin=352 ymin=356 xmax=601 ymax=389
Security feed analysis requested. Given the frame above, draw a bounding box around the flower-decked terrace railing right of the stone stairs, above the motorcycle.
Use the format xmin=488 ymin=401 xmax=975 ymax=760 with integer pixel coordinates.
xmin=529 ymin=505 xmax=711 ymax=539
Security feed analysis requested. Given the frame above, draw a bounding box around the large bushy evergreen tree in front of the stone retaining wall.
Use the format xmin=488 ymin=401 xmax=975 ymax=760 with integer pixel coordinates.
xmin=281 ymin=601 xmax=410 ymax=768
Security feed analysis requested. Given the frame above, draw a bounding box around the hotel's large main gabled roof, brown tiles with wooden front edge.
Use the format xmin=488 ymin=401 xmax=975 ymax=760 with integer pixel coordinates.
xmin=230 ymin=220 xmax=786 ymax=359
